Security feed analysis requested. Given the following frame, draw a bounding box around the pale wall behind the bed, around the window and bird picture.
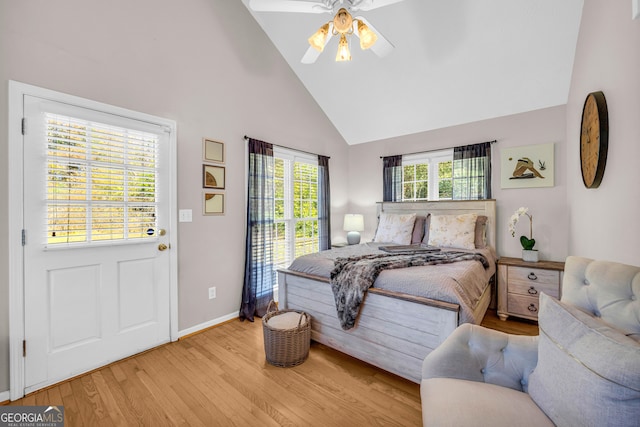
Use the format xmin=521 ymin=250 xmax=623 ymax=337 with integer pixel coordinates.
xmin=349 ymin=106 xmax=568 ymax=260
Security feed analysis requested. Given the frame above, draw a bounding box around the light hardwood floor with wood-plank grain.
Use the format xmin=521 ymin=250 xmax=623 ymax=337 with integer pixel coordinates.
xmin=5 ymin=310 xmax=537 ymax=427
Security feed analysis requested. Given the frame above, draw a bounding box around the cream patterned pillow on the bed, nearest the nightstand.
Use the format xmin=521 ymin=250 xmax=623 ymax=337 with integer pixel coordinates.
xmin=429 ymin=213 xmax=478 ymax=249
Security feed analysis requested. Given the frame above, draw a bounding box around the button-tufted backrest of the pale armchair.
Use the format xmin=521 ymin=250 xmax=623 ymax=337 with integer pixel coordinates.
xmin=561 ymin=256 xmax=640 ymax=341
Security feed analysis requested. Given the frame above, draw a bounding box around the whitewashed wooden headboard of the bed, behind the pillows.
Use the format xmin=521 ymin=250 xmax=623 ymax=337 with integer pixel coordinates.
xmin=378 ymin=199 xmax=496 ymax=248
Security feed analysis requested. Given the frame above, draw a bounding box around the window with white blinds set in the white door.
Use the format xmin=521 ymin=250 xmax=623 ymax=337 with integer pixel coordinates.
xmin=45 ymin=113 xmax=159 ymax=247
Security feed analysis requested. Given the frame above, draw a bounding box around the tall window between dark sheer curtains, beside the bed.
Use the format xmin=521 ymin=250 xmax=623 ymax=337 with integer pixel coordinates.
xmin=273 ymin=147 xmax=320 ymax=269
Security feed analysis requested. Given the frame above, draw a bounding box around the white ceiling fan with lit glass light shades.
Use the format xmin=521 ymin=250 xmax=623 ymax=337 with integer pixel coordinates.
xmin=249 ymin=0 xmax=404 ymax=64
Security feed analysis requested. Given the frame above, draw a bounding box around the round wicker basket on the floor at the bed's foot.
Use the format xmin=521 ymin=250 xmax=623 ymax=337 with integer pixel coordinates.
xmin=262 ymin=301 xmax=311 ymax=368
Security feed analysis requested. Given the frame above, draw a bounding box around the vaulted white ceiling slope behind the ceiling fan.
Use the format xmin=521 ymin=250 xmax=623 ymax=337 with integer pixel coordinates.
xmin=242 ymin=0 xmax=584 ymax=144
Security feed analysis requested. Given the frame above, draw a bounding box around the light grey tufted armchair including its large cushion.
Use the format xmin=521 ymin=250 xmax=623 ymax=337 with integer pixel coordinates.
xmin=420 ymin=257 xmax=640 ymax=427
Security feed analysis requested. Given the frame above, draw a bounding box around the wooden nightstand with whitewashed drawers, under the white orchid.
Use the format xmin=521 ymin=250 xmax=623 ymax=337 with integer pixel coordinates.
xmin=498 ymin=257 xmax=564 ymax=320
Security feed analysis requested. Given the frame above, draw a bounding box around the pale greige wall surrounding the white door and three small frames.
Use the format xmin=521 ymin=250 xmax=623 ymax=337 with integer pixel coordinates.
xmin=0 ymin=0 xmax=348 ymax=400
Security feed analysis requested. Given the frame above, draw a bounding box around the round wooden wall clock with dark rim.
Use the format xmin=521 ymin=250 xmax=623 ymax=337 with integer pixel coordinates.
xmin=580 ymin=92 xmax=609 ymax=188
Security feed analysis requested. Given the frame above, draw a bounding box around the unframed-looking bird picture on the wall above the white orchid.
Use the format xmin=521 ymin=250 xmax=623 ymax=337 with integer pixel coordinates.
xmin=500 ymin=143 xmax=555 ymax=188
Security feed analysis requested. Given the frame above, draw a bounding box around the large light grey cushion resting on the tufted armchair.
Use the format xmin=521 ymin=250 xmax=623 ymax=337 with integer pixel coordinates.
xmin=528 ymin=294 xmax=640 ymax=427
